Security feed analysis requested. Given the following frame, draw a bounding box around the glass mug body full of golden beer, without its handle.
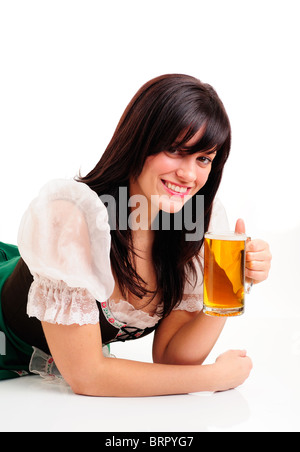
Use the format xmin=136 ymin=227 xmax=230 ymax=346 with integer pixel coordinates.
xmin=204 ymin=233 xmax=247 ymax=316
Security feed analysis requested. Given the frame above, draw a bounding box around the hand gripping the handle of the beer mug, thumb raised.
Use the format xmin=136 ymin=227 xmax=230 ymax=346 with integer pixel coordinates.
xmin=235 ymin=219 xmax=272 ymax=284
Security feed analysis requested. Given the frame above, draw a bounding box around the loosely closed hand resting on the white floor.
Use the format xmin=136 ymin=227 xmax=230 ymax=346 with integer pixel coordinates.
xmin=215 ymin=350 xmax=253 ymax=391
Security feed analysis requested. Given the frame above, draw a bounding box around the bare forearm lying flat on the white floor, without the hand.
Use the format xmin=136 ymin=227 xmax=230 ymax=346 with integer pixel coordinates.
xmin=71 ymin=358 xmax=218 ymax=397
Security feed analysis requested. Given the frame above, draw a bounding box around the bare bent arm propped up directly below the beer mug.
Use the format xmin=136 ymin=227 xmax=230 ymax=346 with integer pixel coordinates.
xmin=153 ymin=311 xmax=226 ymax=365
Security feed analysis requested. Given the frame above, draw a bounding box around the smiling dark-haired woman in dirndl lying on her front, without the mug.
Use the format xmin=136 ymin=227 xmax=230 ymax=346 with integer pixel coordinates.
xmin=0 ymin=74 xmax=271 ymax=397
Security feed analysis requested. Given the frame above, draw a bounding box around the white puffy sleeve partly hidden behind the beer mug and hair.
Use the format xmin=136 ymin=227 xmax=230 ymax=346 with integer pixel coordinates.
xmin=174 ymin=198 xmax=230 ymax=312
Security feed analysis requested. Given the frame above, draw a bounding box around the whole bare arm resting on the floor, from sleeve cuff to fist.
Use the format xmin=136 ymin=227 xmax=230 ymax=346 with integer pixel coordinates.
xmin=43 ymin=322 xmax=252 ymax=397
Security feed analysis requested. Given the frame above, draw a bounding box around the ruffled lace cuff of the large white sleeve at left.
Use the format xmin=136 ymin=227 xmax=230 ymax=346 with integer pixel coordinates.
xmin=27 ymin=275 xmax=99 ymax=325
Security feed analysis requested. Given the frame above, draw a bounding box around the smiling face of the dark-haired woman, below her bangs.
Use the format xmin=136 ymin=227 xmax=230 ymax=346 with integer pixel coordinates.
xmin=130 ymin=129 xmax=216 ymax=213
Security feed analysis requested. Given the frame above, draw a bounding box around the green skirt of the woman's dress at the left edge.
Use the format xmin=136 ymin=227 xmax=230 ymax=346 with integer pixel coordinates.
xmin=0 ymin=242 xmax=33 ymax=380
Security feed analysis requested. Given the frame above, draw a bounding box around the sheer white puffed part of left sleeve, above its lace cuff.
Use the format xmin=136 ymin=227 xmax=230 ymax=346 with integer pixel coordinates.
xmin=18 ymin=179 xmax=114 ymax=300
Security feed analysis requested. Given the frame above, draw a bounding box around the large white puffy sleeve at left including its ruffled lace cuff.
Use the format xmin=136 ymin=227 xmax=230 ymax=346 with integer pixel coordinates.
xmin=18 ymin=180 xmax=115 ymax=325
